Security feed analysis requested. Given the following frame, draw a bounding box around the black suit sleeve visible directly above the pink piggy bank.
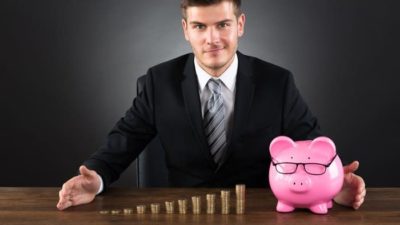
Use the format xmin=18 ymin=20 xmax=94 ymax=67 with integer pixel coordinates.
xmin=283 ymin=72 xmax=321 ymax=140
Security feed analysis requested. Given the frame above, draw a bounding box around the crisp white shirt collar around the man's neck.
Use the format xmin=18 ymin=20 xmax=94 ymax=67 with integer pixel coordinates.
xmin=194 ymin=54 xmax=239 ymax=92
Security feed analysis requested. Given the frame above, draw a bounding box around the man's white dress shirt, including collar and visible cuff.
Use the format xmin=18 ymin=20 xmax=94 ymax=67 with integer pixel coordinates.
xmin=97 ymin=54 xmax=239 ymax=194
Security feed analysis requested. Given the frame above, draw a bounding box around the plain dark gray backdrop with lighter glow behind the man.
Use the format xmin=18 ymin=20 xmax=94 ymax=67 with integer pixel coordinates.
xmin=0 ymin=0 xmax=400 ymax=186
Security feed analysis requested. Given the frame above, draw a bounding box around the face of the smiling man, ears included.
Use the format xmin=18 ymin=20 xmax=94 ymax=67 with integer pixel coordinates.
xmin=182 ymin=1 xmax=245 ymax=76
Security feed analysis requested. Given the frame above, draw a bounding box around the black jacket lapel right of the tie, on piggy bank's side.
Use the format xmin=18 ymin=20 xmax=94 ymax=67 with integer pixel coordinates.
xmin=216 ymin=52 xmax=254 ymax=171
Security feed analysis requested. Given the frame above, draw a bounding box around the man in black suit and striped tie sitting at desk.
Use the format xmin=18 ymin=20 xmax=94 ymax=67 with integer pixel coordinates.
xmin=57 ymin=0 xmax=365 ymax=210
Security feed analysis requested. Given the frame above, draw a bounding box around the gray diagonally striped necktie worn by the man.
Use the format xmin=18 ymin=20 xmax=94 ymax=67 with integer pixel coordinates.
xmin=204 ymin=79 xmax=226 ymax=164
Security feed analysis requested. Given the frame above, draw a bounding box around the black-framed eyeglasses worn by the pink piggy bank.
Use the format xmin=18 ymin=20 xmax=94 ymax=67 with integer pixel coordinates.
xmin=272 ymin=154 xmax=337 ymax=175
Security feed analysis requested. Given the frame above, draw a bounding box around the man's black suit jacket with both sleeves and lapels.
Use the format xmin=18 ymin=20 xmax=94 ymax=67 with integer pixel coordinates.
xmin=84 ymin=52 xmax=320 ymax=187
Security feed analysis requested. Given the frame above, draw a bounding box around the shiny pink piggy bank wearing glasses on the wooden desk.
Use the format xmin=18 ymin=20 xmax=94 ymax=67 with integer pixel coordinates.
xmin=269 ymin=136 xmax=343 ymax=214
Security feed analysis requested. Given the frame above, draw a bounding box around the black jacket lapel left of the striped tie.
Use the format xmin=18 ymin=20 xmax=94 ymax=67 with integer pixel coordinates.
xmin=181 ymin=54 xmax=216 ymax=167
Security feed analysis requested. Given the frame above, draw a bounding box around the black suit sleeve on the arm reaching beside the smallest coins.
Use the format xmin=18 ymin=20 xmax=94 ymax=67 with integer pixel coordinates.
xmin=83 ymin=71 xmax=156 ymax=189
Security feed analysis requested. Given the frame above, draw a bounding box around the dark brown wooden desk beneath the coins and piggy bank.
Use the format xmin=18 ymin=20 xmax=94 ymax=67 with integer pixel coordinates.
xmin=0 ymin=187 xmax=400 ymax=225
